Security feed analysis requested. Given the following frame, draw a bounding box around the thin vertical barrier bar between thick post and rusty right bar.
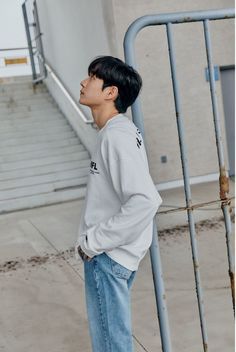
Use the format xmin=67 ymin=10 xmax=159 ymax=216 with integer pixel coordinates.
xmin=166 ymin=23 xmax=208 ymax=352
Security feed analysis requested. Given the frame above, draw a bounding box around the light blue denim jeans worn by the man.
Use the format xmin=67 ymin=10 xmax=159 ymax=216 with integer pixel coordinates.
xmin=84 ymin=253 xmax=135 ymax=352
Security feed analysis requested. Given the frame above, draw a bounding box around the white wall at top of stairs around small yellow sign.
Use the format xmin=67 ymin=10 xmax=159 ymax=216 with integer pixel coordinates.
xmin=0 ymin=0 xmax=31 ymax=77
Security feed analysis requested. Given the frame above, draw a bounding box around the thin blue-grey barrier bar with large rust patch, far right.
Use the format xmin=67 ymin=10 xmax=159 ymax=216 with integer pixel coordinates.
xmin=203 ymin=20 xmax=235 ymax=312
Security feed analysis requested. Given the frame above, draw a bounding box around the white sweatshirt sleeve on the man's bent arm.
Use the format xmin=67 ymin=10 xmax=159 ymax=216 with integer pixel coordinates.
xmin=80 ymin=129 xmax=162 ymax=257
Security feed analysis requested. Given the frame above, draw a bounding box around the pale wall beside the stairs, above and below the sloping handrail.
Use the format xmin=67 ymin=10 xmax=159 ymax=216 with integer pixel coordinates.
xmin=34 ymin=0 xmax=116 ymax=151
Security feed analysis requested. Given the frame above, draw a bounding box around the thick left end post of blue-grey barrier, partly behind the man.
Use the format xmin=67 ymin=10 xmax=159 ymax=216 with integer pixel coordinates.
xmin=124 ymin=24 xmax=172 ymax=352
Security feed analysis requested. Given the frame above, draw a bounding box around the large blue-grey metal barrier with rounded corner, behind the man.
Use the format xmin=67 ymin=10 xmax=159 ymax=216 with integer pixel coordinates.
xmin=124 ymin=9 xmax=235 ymax=352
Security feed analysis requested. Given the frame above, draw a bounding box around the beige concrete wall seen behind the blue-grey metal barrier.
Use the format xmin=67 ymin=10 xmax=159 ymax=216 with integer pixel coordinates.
xmin=113 ymin=0 xmax=234 ymax=183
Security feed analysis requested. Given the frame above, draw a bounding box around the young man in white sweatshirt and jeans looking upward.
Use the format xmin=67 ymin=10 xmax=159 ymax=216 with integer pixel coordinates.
xmin=76 ymin=56 xmax=162 ymax=352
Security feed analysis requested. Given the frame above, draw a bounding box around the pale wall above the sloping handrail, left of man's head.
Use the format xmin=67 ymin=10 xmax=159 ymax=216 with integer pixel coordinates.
xmin=37 ymin=0 xmax=115 ymax=114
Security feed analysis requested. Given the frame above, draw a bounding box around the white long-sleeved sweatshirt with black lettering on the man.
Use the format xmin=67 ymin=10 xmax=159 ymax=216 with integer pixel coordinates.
xmin=76 ymin=114 xmax=162 ymax=271
